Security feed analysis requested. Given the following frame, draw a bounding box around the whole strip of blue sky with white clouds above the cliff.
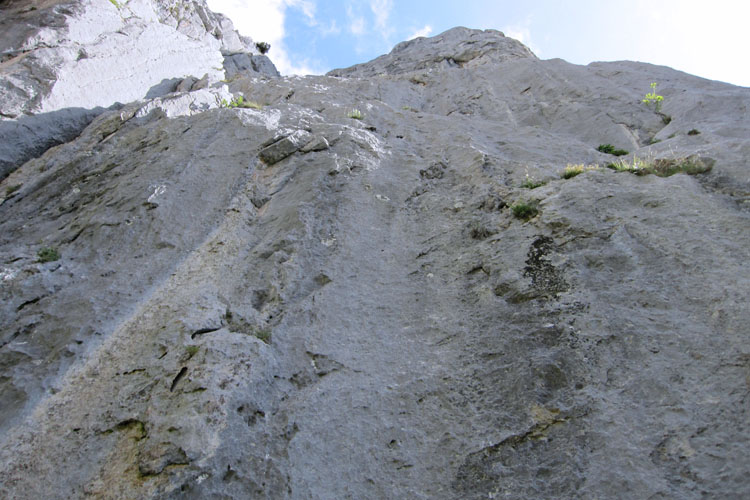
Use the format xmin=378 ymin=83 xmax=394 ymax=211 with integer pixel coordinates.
xmin=208 ymin=0 xmax=750 ymax=87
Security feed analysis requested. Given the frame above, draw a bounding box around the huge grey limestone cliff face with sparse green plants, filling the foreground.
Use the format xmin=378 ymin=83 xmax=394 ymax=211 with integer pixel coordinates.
xmin=0 ymin=6 xmax=750 ymax=499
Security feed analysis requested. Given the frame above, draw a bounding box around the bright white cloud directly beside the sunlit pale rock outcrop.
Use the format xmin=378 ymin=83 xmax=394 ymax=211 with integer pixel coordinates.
xmin=207 ymin=0 xmax=320 ymax=75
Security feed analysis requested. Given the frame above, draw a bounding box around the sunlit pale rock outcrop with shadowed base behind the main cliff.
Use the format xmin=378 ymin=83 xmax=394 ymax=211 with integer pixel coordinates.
xmin=0 ymin=0 xmax=278 ymax=178
